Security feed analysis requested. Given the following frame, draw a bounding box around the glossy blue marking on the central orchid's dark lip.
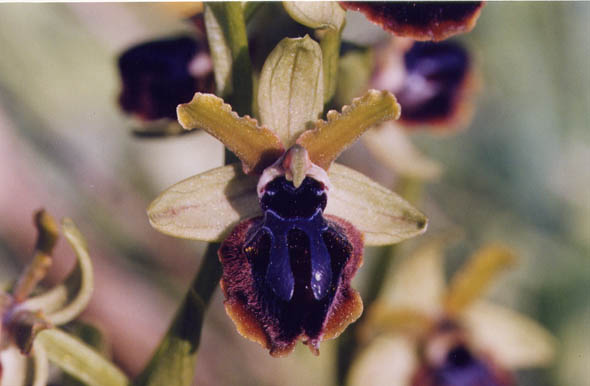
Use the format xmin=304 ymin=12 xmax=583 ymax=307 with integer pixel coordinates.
xmin=246 ymin=177 xmax=332 ymax=301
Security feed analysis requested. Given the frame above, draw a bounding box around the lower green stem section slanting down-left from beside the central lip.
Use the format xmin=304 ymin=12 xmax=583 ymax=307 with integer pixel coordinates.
xmin=134 ymin=243 xmax=221 ymax=386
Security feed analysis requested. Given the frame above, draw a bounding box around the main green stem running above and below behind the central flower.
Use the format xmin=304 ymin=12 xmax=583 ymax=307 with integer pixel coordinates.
xmin=139 ymin=2 xmax=253 ymax=386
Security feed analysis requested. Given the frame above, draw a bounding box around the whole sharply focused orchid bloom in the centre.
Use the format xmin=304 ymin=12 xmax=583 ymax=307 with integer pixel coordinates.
xmin=148 ymin=36 xmax=427 ymax=356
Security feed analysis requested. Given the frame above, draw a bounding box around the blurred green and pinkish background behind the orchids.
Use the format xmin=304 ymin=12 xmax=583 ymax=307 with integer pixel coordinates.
xmin=0 ymin=2 xmax=590 ymax=386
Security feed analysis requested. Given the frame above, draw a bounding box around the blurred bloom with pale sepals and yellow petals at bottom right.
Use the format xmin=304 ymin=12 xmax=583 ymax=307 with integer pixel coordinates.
xmin=348 ymin=240 xmax=555 ymax=386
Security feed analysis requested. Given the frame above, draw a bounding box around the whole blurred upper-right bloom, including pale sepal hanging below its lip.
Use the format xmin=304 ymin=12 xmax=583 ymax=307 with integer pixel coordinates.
xmin=363 ymin=39 xmax=478 ymax=179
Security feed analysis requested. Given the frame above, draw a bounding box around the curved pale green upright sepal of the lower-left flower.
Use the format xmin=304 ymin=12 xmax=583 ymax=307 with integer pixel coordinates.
xmin=21 ymin=218 xmax=94 ymax=325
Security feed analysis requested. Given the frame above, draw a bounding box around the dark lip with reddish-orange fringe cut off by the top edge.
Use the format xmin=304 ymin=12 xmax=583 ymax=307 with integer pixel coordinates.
xmin=340 ymin=1 xmax=484 ymax=41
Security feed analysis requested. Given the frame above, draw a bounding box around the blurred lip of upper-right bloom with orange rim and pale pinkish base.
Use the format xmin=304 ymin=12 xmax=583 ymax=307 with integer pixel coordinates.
xmin=372 ymin=40 xmax=477 ymax=132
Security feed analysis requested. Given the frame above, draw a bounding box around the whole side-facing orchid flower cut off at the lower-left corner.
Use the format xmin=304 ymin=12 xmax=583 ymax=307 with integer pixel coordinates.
xmin=0 ymin=210 xmax=128 ymax=386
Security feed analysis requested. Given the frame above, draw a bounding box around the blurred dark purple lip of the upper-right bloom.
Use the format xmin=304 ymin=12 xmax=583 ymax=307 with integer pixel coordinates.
xmin=395 ymin=42 xmax=470 ymax=124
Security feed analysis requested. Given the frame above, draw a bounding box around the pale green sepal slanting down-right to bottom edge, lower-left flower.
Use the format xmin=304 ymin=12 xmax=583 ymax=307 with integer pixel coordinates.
xmin=35 ymin=329 xmax=129 ymax=386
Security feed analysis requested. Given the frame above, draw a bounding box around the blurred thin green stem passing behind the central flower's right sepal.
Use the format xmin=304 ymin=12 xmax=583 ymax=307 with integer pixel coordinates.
xmin=336 ymin=178 xmax=423 ymax=385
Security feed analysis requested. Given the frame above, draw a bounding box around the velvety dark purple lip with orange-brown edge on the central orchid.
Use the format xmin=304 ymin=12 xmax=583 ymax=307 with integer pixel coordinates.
xmin=219 ymin=176 xmax=362 ymax=355
